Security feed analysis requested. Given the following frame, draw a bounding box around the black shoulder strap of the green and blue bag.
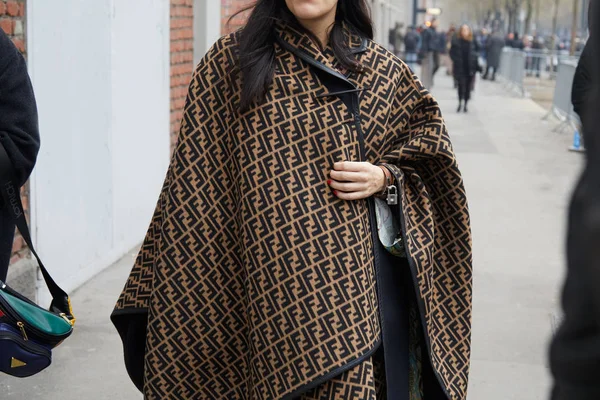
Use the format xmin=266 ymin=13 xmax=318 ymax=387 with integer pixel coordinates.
xmin=0 ymin=144 xmax=74 ymax=320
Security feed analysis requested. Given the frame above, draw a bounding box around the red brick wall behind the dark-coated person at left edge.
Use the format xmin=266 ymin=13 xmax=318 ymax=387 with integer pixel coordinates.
xmin=0 ymin=0 xmax=29 ymax=264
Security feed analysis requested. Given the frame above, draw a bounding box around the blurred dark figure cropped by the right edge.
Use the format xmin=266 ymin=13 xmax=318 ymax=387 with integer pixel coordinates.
xmin=550 ymin=0 xmax=600 ymax=400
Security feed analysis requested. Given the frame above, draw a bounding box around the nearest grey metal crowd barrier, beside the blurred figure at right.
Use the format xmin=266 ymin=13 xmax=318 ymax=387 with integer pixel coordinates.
xmin=543 ymin=60 xmax=579 ymax=130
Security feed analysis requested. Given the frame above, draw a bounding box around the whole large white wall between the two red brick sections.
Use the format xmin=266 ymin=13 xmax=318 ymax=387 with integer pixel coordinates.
xmin=27 ymin=0 xmax=169 ymax=302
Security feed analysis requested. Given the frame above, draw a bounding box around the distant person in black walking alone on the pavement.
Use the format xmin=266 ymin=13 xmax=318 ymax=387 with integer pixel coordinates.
xmin=450 ymin=25 xmax=481 ymax=112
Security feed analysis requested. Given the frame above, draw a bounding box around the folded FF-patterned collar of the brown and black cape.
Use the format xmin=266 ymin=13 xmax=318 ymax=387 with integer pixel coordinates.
xmin=275 ymin=21 xmax=367 ymax=79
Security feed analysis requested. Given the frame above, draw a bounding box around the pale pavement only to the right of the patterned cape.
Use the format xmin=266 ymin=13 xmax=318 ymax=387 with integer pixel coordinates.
xmin=432 ymin=71 xmax=583 ymax=400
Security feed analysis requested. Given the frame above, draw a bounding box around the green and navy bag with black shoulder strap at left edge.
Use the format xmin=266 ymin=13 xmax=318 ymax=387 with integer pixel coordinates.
xmin=0 ymin=145 xmax=75 ymax=377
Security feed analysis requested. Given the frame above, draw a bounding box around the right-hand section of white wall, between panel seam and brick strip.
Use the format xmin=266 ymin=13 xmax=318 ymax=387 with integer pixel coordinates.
xmin=111 ymin=0 xmax=170 ymax=260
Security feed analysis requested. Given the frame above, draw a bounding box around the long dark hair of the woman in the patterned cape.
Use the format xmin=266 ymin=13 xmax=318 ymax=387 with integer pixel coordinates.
xmin=229 ymin=0 xmax=373 ymax=112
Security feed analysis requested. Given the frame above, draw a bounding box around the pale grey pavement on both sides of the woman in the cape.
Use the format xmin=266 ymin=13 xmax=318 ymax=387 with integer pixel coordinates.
xmin=0 ymin=70 xmax=582 ymax=400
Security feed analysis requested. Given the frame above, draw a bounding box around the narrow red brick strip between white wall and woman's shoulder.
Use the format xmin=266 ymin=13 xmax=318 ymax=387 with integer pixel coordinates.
xmin=171 ymin=0 xmax=194 ymax=149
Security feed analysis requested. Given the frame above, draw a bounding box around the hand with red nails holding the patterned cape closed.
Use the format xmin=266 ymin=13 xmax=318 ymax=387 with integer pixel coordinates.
xmin=327 ymin=161 xmax=386 ymax=200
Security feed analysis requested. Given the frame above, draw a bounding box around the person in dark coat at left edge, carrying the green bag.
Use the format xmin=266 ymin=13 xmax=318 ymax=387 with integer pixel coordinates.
xmin=0 ymin=29 xmax=40 ymax=281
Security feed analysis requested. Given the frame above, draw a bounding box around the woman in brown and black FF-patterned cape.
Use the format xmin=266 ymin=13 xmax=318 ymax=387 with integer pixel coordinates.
xmin=112 ymin=0 xmax=472 ymax=400
